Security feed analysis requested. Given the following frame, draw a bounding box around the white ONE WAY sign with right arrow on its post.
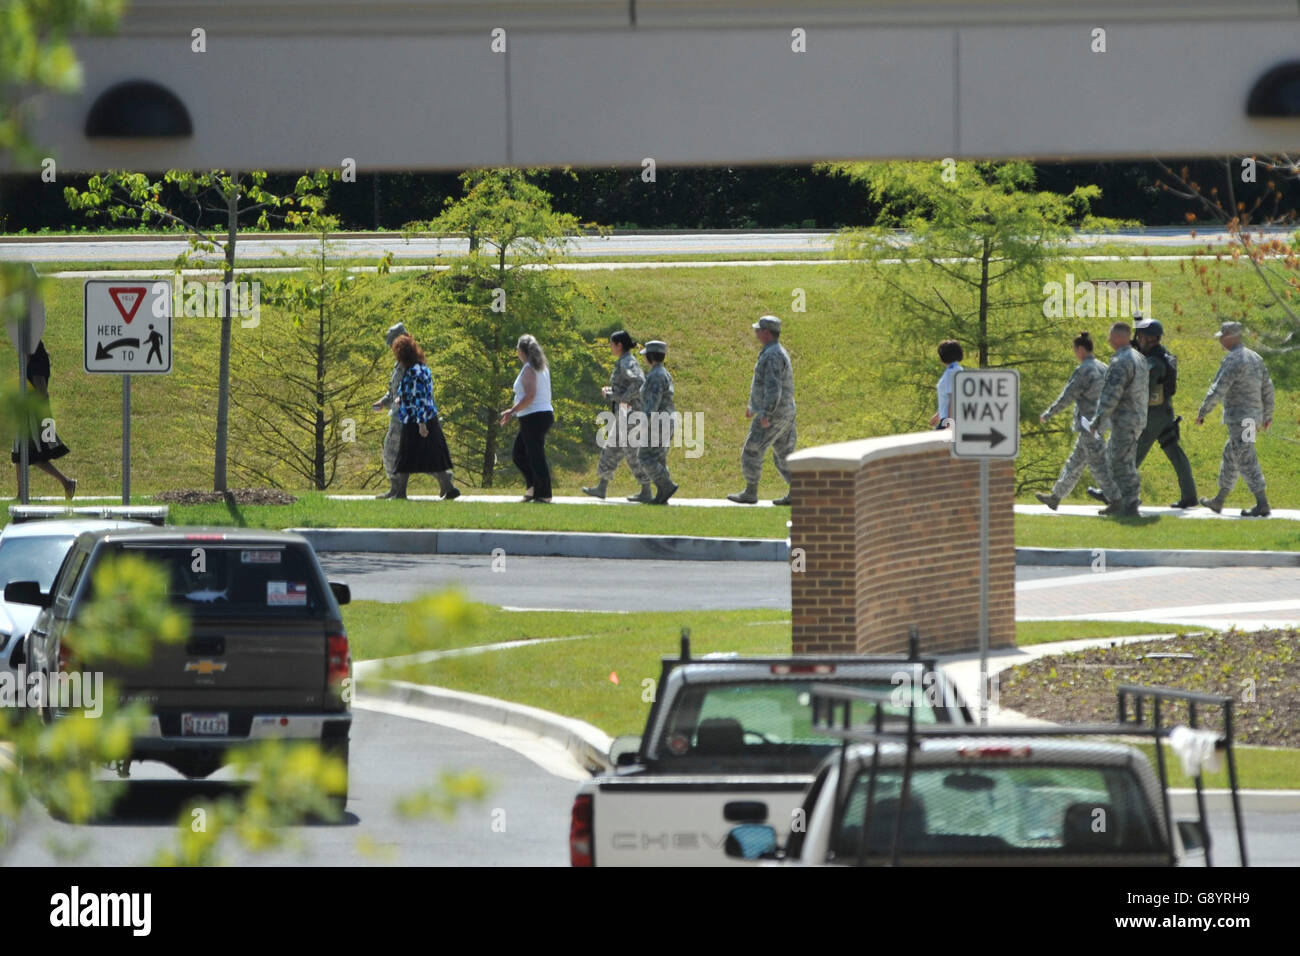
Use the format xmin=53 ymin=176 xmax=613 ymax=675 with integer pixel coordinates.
xmin=950 ymin=368 xmax=1021 ymax=726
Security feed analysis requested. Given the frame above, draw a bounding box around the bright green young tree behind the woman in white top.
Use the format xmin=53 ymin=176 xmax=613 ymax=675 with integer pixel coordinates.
xmin=407 ymin=169 xmax=601 ymax=488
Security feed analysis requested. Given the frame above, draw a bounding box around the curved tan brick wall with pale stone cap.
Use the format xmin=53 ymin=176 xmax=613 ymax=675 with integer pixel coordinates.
xmin=789 ymin=432 xmax=1015 ymax=654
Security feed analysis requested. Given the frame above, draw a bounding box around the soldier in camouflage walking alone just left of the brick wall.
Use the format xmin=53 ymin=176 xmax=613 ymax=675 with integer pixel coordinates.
xmin=727 ymin=315 xmax=794 ymax=505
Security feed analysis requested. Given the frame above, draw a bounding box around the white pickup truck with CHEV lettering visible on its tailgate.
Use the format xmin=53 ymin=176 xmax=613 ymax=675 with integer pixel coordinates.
xmin=569 ymin=637 xmax=971 ymax=866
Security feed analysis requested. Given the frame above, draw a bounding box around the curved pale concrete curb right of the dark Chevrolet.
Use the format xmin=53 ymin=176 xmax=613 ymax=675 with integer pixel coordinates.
xmin=356 ymin=678 xmax=614 ymax=775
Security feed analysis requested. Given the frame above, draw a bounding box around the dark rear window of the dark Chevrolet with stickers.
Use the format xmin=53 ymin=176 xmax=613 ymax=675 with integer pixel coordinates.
xmin=100 ymin=541 xmax=328 ymax=618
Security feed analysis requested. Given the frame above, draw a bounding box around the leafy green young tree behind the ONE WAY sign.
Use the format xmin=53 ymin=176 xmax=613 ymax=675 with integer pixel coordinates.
xmin=820 ymin=160 xmax=1114 ymax=490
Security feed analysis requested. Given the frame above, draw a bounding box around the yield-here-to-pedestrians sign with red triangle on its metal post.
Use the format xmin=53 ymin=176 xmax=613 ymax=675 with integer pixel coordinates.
xmin=82 ymin=278 xmax=172 ymax=505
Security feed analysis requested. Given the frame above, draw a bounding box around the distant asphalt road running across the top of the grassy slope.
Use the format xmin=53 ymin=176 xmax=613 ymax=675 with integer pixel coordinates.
xmin=0 ymin=226 xmax=1279 ymax=263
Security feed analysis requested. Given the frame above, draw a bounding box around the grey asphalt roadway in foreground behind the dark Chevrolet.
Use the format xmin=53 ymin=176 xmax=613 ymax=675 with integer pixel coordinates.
xmin=0 ymin=709 xmax=577 ymax=866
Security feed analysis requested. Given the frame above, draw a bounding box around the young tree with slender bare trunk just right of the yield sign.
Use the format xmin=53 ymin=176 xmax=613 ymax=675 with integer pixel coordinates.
xmin=64 ymin=169 xmax=337 ymax=492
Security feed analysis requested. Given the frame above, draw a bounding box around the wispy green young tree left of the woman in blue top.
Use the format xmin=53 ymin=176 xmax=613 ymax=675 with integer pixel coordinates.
xmin=231 ymin=215 xmax=387 ymax=490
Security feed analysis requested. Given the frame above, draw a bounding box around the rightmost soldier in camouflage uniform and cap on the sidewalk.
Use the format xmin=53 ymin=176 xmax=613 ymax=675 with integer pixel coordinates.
xmin=1196 ymin=323 xmax=1273 ymax=518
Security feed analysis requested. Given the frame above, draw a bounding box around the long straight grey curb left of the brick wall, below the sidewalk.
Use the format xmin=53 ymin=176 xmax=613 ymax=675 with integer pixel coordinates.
xmin=286 ymin=528 xmax=790 ymax=561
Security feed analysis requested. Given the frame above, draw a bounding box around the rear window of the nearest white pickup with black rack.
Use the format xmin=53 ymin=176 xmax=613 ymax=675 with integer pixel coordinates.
xmin=833 ymin=762 xmax=1164 ymax=862
